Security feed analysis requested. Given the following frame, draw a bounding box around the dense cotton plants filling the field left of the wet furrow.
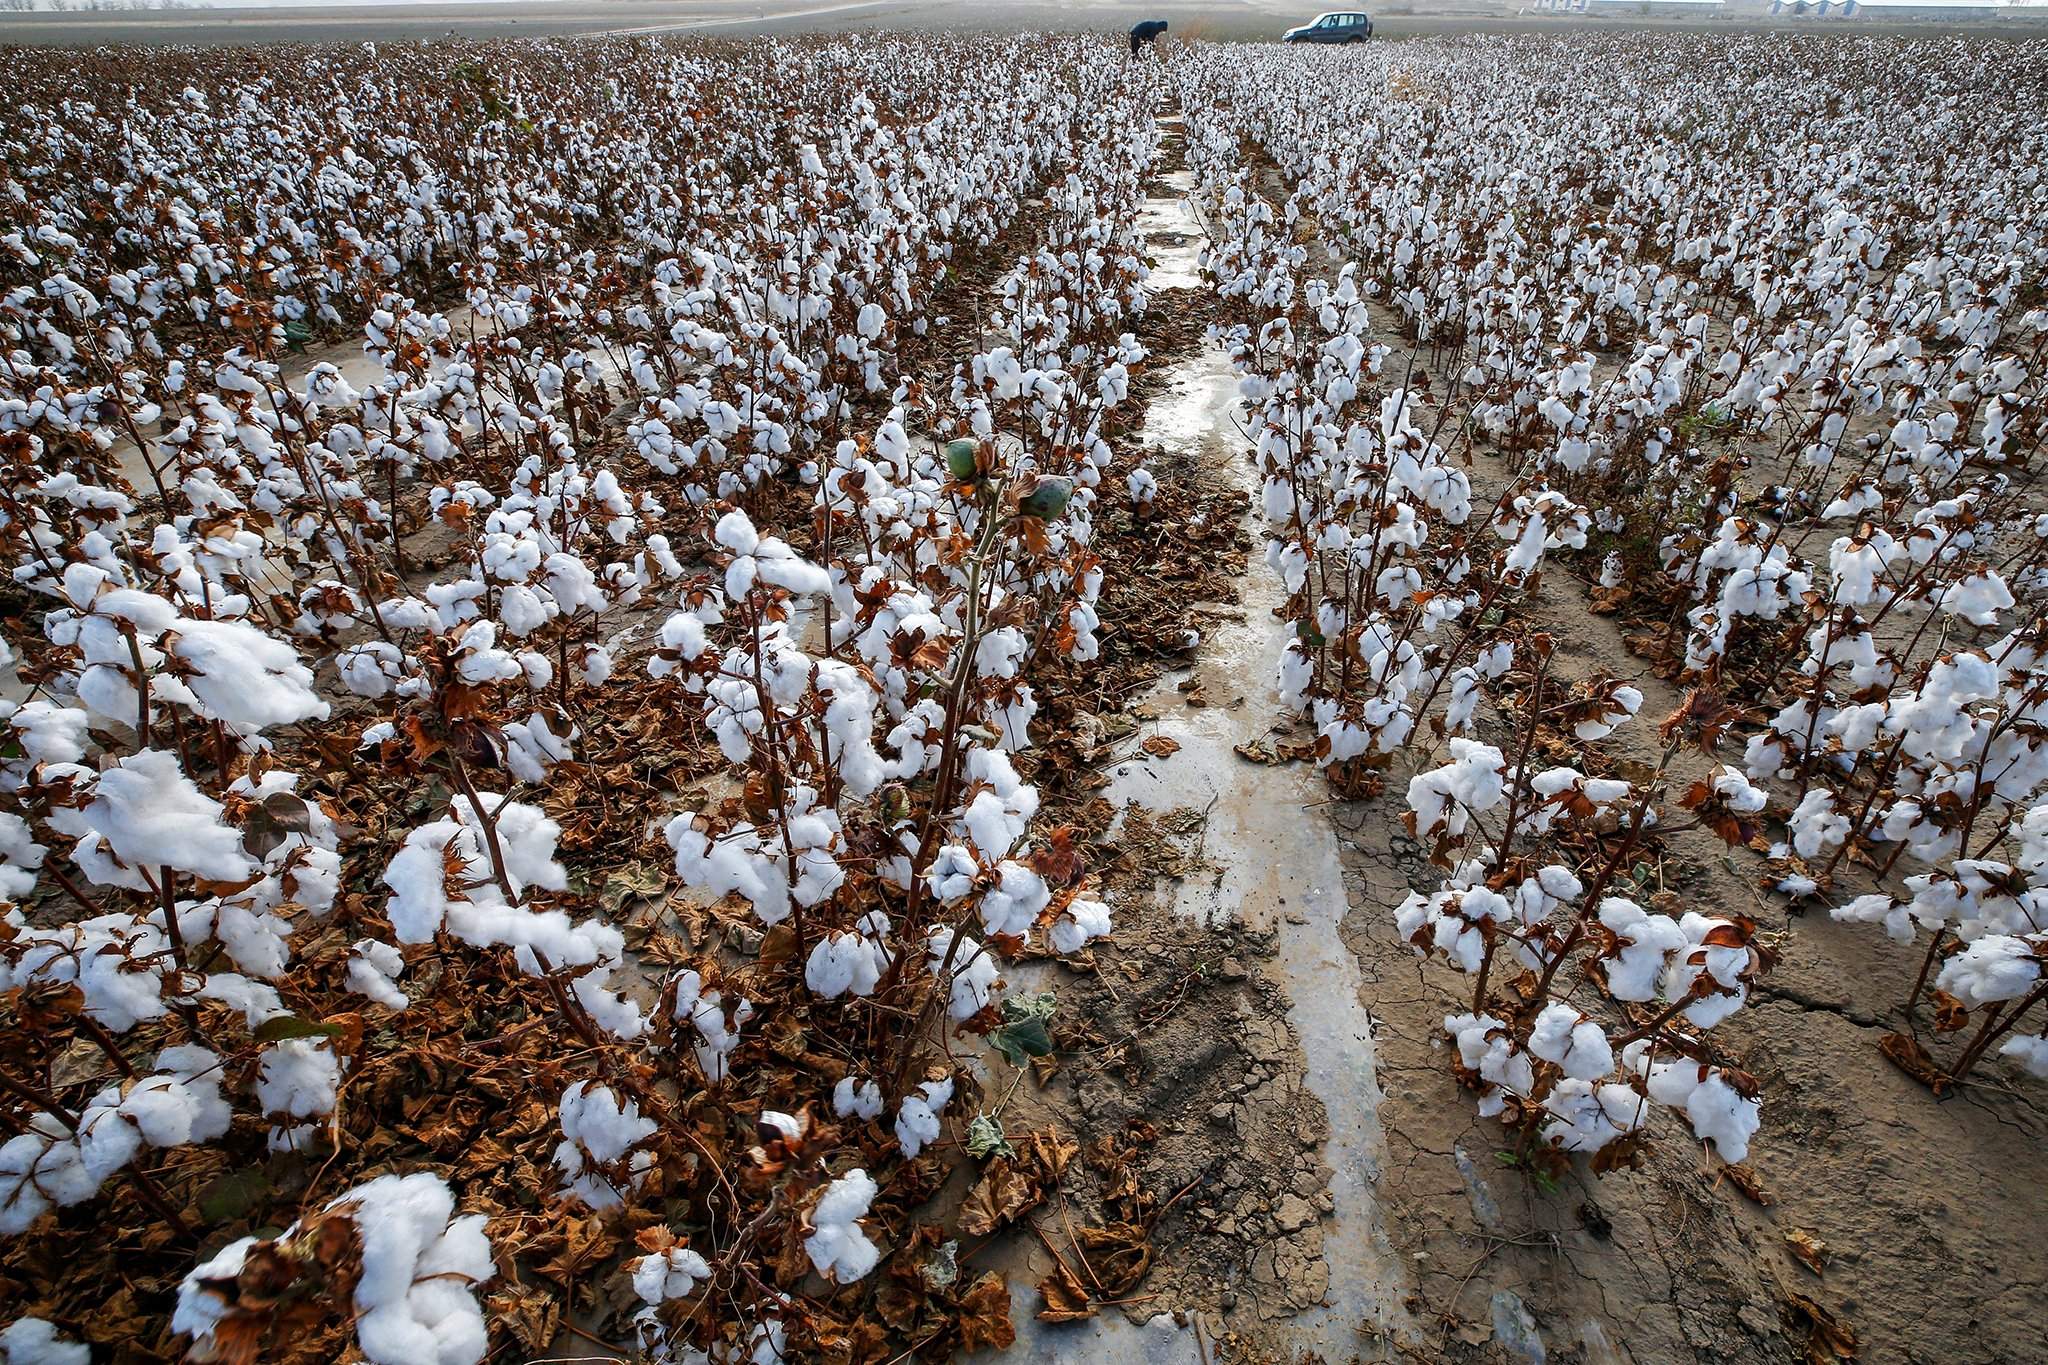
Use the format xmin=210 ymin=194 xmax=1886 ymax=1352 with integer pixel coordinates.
xmin=0 ymin=39 xmax=1157 ymax=1365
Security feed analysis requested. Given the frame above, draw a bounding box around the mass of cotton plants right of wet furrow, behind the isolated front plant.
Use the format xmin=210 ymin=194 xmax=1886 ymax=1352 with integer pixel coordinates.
xmin=1180 ymin=29 xmax=2048 ymax=1154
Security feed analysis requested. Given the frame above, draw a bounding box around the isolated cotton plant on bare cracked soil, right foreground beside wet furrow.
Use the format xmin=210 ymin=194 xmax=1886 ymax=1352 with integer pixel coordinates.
xmin=1395 ymin=679 xmax=1769 ymax=1171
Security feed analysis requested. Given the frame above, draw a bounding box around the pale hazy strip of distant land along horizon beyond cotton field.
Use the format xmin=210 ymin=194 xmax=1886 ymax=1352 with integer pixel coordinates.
xmin=0 ymin=0 xmax=2048 ymax=47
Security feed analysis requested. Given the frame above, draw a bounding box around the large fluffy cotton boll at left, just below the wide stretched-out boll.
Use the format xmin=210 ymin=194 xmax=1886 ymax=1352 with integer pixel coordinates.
xmin=84 ymin=749 xmax=256 ymax=882
